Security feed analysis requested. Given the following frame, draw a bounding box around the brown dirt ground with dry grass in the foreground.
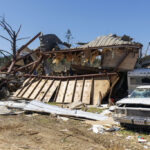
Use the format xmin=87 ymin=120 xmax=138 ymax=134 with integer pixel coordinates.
xmin=0 ymin=114 xmax=149 ymax=150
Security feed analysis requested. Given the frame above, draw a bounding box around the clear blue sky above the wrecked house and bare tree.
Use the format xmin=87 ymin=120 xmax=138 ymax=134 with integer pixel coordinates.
xmin=0 ymin=0 xmax=150 ymax=53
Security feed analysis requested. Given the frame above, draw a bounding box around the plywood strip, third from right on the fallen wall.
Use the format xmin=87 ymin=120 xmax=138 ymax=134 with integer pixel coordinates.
xmin=73 ymin=80 xmax=83 ymax=102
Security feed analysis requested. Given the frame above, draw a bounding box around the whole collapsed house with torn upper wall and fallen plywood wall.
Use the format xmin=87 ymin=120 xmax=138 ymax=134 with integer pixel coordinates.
xmin=0 ymin=32 xmax=142 ymax=105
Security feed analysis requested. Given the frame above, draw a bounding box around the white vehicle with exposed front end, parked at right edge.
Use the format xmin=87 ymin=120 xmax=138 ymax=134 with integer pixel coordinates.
xmin=114 ymin=85 xmax=150 ymax=126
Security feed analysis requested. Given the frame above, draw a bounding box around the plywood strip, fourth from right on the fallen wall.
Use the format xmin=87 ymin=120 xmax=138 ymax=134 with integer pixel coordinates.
xmin=64 ymin=80 xmax=75 ymax=103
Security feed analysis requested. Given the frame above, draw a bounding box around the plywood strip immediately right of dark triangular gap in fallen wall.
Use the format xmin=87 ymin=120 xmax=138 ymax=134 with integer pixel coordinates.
xmin=56 ymin=81 xmax=67 ymax=103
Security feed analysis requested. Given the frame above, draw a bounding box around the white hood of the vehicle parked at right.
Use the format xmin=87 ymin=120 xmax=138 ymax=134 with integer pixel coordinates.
xmin=117 ymin=98 xmax=150 ymax=105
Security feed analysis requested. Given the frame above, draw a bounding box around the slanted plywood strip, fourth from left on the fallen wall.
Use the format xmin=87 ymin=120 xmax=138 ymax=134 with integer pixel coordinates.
xmin=36 ymin=80 xmax=53 ymax=101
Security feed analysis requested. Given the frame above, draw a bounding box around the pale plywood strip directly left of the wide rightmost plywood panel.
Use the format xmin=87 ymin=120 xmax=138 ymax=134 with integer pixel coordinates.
xmin=82 ymin=79 xmax=92 ymax=104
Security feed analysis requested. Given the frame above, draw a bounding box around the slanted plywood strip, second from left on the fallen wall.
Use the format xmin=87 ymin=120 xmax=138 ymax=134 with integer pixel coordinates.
xmin=22 ymin=79 xmax=39 ymax=98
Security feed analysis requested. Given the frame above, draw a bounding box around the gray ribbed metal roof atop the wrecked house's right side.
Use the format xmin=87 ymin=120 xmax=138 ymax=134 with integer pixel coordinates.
xmin=80 ymin=34 xmax=140 ymax=48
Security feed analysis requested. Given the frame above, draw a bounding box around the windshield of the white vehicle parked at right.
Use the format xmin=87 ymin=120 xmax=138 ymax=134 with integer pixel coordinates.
xmin=130 ymin=88 xmax=150 ymax=98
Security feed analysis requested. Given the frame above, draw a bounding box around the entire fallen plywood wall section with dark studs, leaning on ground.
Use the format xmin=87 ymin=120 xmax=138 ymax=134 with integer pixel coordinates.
xmin=14 ymin=77 xmax=110 ymax=105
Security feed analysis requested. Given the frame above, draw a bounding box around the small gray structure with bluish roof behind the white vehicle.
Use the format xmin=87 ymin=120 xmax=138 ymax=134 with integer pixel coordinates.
xmin=128 ymin=68 xmax=150 ymax=94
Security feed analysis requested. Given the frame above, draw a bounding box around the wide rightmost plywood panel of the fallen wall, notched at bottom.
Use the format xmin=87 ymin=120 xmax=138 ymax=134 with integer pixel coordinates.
xmin=93 ymin=79 xmax=110 ymax=105
